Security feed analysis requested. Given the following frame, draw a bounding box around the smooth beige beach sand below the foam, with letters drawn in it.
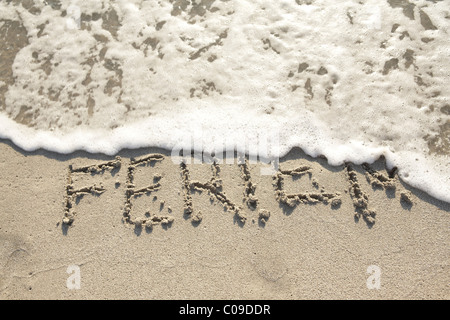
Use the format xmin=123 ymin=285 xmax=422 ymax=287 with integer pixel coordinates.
xmin=0 ymin=140 xmax=450 ymax=299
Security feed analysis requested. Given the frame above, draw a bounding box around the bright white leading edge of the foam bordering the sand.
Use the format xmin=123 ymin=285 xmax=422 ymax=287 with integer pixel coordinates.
xmin=0 ymin=115 xmax=450 ymax=203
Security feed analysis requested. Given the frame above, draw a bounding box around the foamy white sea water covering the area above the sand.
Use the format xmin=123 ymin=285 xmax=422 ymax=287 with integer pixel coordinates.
xmin=0 ymin=0 xmax=450 ymax=202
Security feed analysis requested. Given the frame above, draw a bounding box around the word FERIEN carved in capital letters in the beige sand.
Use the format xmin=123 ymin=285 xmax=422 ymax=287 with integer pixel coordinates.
xmin=62 ymin=153 xmax=412 ymax=230
